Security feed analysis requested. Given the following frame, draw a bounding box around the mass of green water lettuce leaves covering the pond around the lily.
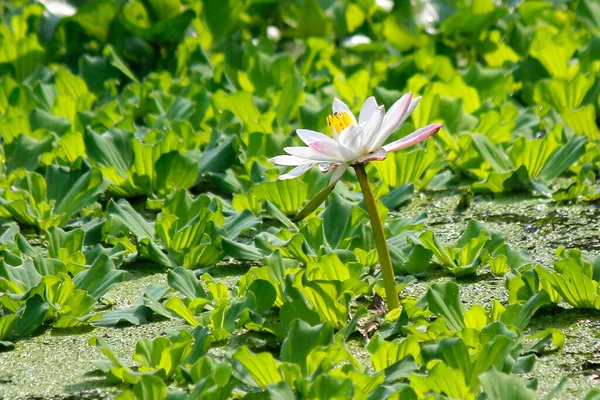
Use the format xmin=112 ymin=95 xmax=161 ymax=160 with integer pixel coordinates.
xmin=0 ymin=0 xmax=600 ymax=399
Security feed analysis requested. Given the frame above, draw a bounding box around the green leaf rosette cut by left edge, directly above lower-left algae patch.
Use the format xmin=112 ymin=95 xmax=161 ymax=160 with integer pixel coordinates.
xmin=0 ymin=229 xmax=123 ymax=348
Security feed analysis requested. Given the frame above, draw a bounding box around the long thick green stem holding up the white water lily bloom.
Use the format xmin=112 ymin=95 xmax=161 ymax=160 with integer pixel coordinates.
xmin=353 ymin=164 xmax=400 ymax=311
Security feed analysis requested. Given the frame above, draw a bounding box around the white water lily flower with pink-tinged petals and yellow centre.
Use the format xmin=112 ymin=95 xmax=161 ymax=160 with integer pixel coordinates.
xmin=269 ymin=93 xmax=442 ymax=185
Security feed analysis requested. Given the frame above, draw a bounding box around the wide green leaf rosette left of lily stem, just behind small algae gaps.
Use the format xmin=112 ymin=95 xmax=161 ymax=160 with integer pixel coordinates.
xmin=106 ymin=190 xmax=260 ymax=269
